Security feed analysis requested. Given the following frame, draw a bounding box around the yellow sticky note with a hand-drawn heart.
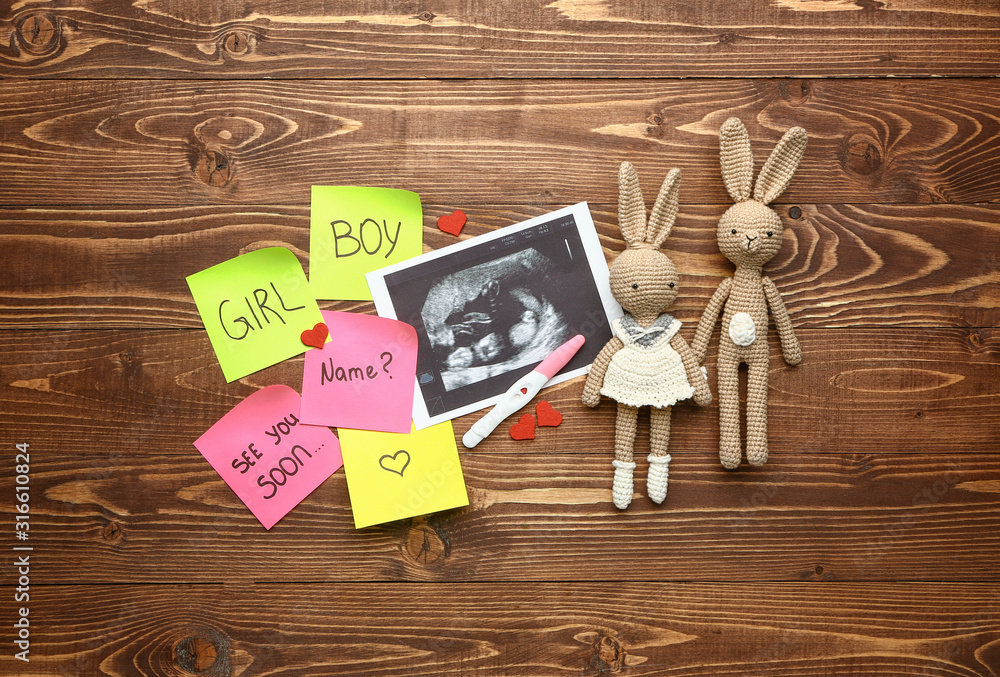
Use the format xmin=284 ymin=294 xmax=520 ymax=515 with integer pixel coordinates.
xmin=338 ymin=421 xmax=469 ymax=529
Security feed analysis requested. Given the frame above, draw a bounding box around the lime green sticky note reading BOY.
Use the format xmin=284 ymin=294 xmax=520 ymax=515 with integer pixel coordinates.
xmin=309 ymin=186 xmax=424 ymax=301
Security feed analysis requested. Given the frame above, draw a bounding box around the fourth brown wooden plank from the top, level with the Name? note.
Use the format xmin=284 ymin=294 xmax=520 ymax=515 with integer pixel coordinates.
xmin=0 ymin=327 xmax=1000 ymax=462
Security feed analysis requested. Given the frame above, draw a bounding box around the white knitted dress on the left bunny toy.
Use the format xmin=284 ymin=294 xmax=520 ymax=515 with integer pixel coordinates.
xmin=601 ymin=313 xmax=694 ymax=407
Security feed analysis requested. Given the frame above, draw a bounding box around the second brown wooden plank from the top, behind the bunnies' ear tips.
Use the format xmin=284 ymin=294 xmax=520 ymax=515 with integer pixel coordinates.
xmin=0 ymin=79 xmax=1000 ymax=207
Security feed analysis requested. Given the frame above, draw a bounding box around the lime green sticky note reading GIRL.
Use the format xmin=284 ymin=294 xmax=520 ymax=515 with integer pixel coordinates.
xmin=187 ymin=247 xmax=323 ymax=382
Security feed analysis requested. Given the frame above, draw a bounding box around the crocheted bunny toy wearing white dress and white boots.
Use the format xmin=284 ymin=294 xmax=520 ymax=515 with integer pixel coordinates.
xmin=583 ymin=162 xmax=712 ymax=510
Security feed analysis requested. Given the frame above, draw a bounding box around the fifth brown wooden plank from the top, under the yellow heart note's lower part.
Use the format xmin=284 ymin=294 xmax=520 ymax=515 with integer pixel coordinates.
xmin=11 ymin=446 xmax=1000 ymax=585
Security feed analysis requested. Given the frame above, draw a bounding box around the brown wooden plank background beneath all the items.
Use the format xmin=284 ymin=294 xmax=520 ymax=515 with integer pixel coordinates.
xmin=0 ymin=0 xmax=1000 ymax=677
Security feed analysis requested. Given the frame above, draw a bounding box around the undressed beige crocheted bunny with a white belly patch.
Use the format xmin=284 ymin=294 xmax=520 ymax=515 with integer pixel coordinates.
xmin=692 ymin=118 xmax=808 ymax=469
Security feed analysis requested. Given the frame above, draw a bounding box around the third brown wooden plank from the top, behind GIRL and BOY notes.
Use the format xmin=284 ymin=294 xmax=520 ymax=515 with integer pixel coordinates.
xmin=0 ymin=202 xmax=1000 ymax=329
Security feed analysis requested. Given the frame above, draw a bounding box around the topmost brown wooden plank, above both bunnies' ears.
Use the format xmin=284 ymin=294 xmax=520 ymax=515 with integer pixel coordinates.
xmin=0 ymin=0 xmax=1000 ymax=78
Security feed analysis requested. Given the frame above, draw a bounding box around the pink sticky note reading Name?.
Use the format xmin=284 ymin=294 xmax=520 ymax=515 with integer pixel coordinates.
xmin=302 ymin=310 xmax=417 ymax=433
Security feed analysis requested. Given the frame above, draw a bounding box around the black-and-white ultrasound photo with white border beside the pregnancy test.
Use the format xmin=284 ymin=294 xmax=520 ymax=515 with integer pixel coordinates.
xmin=369 ymin=203 xmax=621 ymax=428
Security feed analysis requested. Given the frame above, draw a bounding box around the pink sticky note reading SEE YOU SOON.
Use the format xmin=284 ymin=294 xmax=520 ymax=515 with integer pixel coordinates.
xmin=194 ymin=385 xmax=344 ymax=529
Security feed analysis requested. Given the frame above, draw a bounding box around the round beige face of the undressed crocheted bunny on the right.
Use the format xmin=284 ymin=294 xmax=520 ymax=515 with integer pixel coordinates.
xmin=717 ymin=200 xmax=785 ymax=268
